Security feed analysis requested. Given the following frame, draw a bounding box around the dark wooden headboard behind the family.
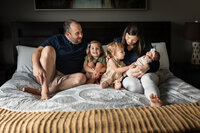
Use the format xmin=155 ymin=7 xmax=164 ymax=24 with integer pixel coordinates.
xmin=11 ymin=22 xmax=171 ymax=63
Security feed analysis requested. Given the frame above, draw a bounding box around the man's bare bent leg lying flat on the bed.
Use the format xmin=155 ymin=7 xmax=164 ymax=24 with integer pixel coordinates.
xmin=49 ymin=73 xmax=86 ymax=93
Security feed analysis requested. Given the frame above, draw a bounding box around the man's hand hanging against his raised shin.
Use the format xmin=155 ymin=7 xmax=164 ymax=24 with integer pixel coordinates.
xmin=33 ymin=67 xmax=46 ymax=85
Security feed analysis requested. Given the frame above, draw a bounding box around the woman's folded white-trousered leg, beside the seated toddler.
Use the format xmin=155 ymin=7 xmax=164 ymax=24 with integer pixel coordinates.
xmin=122 ymin=77 xmax=144 ymax=93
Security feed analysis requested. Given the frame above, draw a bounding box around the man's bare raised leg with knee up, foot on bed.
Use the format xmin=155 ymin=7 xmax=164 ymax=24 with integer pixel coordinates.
xmin=40 ymin=46 xmax=56 ymax=99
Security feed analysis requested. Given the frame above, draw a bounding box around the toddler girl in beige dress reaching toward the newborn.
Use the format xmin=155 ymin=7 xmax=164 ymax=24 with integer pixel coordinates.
xmin=100 ymin=42 xmax=133 ymax=90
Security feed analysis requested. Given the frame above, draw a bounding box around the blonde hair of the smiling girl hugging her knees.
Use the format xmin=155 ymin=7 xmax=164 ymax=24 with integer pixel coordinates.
xmin=86 ymin=40 xmax=105 ymax=62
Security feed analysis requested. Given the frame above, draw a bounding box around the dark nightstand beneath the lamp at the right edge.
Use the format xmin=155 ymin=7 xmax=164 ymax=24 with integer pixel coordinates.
xmin=172 ymin=63 xmax=200 ymax=89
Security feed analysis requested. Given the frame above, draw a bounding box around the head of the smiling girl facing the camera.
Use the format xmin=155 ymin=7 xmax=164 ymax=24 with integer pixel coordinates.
xmin=86 ymin=40 xmax=104 ymax=60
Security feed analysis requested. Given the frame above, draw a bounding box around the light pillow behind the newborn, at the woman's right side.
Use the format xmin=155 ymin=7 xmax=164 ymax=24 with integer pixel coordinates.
xmin=151 ymin=42 xmax=169 ymax=69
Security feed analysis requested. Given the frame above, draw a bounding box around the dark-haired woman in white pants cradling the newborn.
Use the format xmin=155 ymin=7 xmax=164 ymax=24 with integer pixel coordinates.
xmin=114 ymin=23 xmax=162 ymax=106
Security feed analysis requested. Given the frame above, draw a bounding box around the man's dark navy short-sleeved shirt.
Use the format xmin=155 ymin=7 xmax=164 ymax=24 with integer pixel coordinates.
xmin=41 ymin=34 xmax=87 ymax=74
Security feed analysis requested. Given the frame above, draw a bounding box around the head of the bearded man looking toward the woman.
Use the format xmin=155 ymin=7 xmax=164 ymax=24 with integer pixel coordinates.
xmin=65 ymin=22 xmax=83 ymax=44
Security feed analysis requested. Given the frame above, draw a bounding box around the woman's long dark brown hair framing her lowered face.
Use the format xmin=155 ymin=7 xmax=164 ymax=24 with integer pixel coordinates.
xmin=122 ymin=23 xmax=145 ymax=56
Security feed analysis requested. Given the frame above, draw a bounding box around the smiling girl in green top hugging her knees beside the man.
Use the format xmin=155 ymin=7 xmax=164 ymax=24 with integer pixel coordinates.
xmin=83 ymin=41 xmax=106 ymax=84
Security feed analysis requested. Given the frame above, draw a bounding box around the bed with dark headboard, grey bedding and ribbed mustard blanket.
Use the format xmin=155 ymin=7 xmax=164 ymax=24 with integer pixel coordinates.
xmin=0 ymin=22 xmax=200 ymax=133
